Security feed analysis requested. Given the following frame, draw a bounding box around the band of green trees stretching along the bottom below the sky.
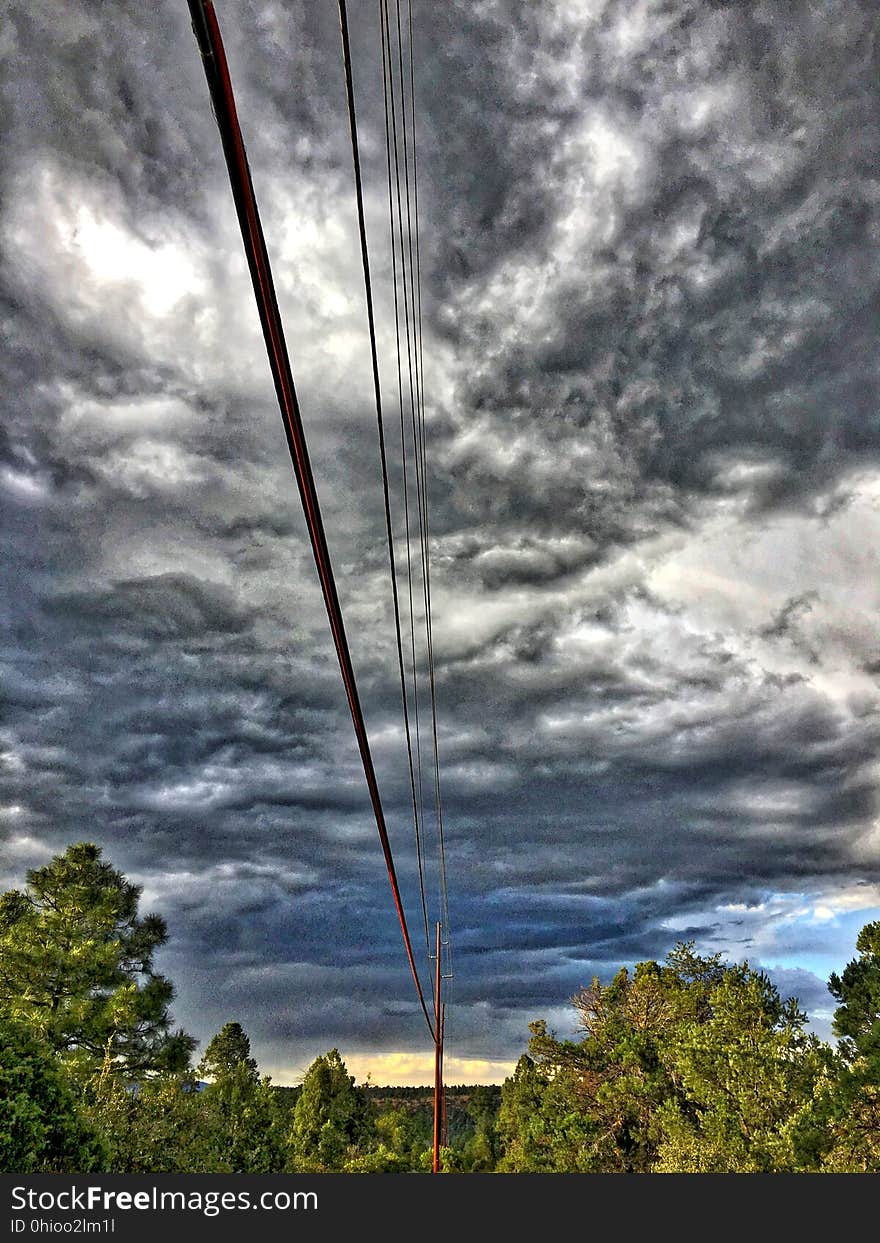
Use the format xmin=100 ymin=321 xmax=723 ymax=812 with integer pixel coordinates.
xmin=0 ymin=843 xmax=880 ymax=1173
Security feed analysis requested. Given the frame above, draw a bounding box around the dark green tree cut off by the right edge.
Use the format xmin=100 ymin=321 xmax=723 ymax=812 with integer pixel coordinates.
xmin=825 ymin=922 xmax=880 ymax=1173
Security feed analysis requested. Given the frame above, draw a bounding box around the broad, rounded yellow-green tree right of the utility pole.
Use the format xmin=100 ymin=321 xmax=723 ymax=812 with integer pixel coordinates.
xmin=498 ymin=945 xmax=828 ymax=1173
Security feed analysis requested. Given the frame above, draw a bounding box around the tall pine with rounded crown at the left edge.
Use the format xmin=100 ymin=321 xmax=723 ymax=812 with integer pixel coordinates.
xmin=0 ymin=842 xmax=195 ymax=1075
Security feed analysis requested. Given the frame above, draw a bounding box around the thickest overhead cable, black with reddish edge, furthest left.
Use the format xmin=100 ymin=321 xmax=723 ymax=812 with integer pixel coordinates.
xmin=188 ymin=0 xmax=439 ymax=1042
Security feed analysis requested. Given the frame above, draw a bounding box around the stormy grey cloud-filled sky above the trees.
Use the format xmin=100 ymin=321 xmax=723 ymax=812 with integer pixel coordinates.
xmin=0 ymin=0 xmax=880 ymax=1081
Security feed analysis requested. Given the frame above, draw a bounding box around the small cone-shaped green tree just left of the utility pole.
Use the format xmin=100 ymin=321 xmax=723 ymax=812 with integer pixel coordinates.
xmin=290 ymin=1049 xmax=375 ymax=1170
